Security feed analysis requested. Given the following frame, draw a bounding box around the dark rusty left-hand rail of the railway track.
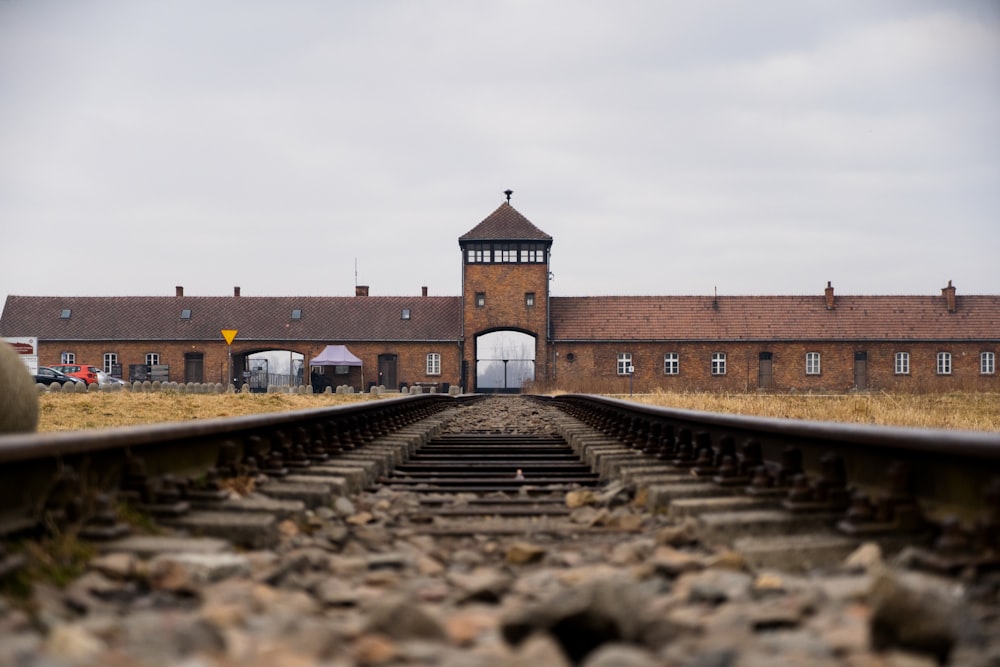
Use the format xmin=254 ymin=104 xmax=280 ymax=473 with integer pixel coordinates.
xmin=0 ymin=394 xmax=464 ymax=534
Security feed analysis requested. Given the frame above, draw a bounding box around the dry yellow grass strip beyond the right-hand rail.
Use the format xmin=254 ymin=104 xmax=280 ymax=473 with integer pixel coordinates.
xmin=617 ymin=392 xmax=1000 ymax=431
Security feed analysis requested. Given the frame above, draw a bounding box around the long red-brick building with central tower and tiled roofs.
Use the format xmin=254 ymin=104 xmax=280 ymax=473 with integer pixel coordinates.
xmin=0 ymin=199 xmax=1000 ymax=393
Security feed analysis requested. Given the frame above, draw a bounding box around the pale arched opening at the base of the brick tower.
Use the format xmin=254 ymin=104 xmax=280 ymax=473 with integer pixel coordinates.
xmin=476 ymin=329 xmax=535 ymax=394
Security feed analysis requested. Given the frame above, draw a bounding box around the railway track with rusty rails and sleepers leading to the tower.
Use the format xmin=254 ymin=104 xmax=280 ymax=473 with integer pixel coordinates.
xmin=0 ymin=395 xmax=1000 ymax=664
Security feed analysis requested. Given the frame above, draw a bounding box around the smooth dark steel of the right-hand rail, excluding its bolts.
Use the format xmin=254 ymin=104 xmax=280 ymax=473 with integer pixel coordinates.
xmin=545 ymin=394 xmax=1000 ymax=521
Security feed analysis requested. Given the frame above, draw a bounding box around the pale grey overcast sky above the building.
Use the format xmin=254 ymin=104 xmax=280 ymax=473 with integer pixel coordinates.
xmin=0 ymin=0 xmax=1000 ymax=310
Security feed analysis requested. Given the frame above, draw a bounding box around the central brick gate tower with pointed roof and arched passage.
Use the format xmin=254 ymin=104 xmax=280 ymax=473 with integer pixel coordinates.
xmin=458 ymin=191 xmax=552 ymax=391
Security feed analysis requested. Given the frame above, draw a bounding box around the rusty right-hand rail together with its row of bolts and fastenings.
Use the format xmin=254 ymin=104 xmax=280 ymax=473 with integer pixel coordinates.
xmin=548 ymin=395 xmax=1000 ymax=556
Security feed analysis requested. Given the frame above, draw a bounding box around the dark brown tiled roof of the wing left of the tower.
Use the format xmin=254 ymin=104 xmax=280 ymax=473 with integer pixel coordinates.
xmin=0 ymin=296 xmax=462 ymax=341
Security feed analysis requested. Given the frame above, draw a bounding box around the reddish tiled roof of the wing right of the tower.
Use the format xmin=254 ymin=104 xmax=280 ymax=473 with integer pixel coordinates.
xmin=551 ymin=295 xmax=1000 ymax=341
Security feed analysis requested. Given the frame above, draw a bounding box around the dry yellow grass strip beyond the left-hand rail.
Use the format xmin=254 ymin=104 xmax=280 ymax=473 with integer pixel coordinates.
xmin=38 ymin=392 xmax=374 ymax=432
